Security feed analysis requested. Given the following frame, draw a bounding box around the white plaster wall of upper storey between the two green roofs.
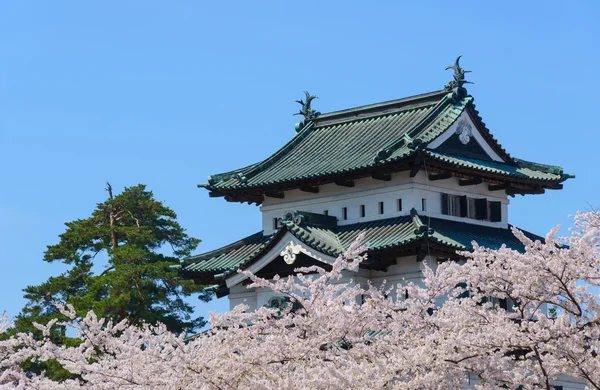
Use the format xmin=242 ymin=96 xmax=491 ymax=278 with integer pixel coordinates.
xmin=261 ymin=170 xmax=509 ymax=234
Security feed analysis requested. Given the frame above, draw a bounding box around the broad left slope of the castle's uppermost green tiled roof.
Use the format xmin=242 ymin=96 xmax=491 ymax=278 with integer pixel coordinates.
xmin=206 ymin=94 xmax=448 ymax=190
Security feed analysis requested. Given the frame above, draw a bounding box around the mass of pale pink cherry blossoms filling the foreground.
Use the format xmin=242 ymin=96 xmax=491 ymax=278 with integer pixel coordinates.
xmin=0 ymin=212 xmax=600 ymax=389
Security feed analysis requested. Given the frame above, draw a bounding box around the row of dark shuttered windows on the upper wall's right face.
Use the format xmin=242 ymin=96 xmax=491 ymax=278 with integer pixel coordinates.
xmin=442 ymin=194 xmax=502 ymax=222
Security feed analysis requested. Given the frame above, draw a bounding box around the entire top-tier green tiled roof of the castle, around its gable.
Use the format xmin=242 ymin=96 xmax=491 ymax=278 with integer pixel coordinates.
xmin=200 ymin=91 xmax=568 ymax=200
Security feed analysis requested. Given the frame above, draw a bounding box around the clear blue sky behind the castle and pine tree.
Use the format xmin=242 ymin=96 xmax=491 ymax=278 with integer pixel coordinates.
xmin=0 ymin=0 xmax=600 ymax=324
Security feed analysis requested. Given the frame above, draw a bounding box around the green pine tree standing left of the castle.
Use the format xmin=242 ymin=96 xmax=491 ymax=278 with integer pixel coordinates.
xmin=8 ymin=183 xmax=210 ymax=338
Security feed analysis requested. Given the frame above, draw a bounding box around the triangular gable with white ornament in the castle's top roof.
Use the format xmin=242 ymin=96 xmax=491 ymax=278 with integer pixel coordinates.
xmin=427 ymin=111 xmax=505 ymax=162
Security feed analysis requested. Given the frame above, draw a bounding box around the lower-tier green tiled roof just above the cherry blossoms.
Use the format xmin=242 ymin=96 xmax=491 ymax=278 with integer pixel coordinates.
xmin=181 ymin=213 xmax=541 ymax=278
